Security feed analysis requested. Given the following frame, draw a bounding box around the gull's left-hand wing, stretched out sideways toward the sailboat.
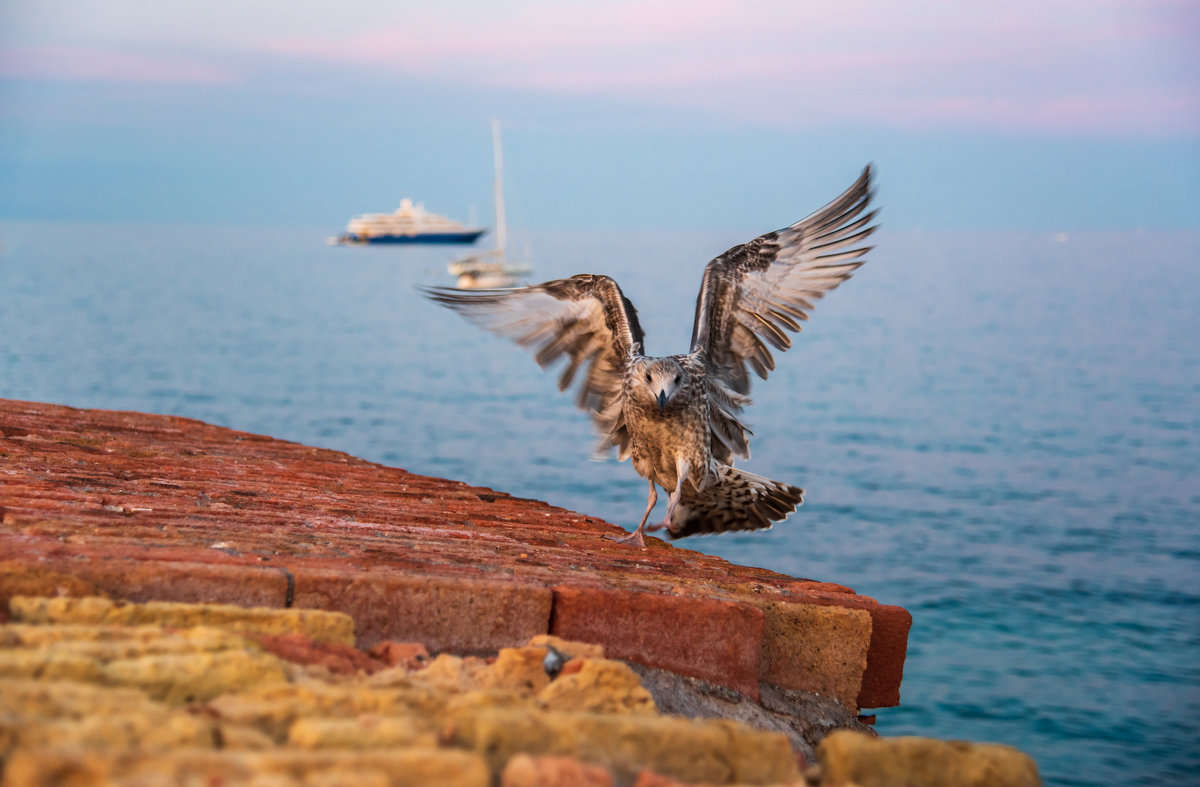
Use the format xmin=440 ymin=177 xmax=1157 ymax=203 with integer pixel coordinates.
xmin=425 ymin=274 xmax=644 ymax=458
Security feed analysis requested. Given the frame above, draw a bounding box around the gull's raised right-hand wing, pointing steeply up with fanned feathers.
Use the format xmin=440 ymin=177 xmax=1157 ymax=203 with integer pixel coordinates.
xmin=691 ymin=166 xmax=876 ymax=395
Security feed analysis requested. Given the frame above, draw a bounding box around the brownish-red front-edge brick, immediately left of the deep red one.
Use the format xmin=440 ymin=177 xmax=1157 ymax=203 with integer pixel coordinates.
xmin=295 ymin=567 xmax=552 ymax=653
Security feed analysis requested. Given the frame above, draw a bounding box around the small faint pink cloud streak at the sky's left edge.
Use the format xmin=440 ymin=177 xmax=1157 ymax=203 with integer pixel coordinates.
xmin=0 ymin=46 xmax=238 ymax=84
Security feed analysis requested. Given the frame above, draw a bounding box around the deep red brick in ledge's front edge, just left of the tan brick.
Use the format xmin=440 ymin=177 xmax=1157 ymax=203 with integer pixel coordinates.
xmin=550 ymin=585 xmax=763 ymax=699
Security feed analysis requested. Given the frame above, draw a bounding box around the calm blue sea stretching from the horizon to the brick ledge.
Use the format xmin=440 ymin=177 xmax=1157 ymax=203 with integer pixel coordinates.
xmin=0 ymin=223 xmax=1200 ymax=785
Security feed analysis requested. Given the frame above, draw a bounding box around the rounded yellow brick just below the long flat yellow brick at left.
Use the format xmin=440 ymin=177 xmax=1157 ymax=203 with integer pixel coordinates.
xmin=102 ymin=650 xmax=287 ymax=704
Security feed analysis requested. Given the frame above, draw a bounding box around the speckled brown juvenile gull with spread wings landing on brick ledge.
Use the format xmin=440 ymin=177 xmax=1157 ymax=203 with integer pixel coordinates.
xmin=425 ymin=166 xmax=877 ymax=546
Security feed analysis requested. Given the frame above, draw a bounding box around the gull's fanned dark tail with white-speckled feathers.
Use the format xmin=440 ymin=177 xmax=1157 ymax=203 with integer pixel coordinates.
xmin=667 ymin=464 xmax=804 ymax=539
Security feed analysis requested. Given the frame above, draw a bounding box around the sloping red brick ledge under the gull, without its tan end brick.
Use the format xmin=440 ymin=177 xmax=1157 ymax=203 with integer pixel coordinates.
xmin=0 ymin=399 xmax=911 ymax=708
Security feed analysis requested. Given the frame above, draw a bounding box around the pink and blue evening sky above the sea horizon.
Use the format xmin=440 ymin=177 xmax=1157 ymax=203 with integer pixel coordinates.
xmin=0 ymin=0 xmax=1200 ymax=234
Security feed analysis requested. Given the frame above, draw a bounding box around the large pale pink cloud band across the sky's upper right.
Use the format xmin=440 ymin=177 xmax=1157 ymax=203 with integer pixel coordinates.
xmin=255 ymin=0 xmax=1200 ymax=133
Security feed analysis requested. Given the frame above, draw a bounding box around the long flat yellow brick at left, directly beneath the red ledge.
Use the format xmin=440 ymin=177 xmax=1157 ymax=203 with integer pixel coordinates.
xmin=8 ymin=596 xmax=354 ymax=645
